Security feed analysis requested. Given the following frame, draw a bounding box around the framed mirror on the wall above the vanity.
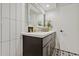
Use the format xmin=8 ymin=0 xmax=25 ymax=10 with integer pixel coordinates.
xmin=28 ymin=3 xmax=44 ymax=26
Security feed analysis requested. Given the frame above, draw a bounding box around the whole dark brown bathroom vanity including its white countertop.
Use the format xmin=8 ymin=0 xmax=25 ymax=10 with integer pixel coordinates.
xmin=22 ymin=31 xmax=56 ymax=56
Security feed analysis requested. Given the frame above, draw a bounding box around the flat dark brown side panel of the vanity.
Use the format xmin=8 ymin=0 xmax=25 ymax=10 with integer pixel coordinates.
xmin=23 ymin=35 xmax=42 ymax=56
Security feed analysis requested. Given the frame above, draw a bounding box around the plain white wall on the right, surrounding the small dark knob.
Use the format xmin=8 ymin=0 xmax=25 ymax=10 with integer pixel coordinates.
xmin=57 ymin=4 xmax=79 ymax=54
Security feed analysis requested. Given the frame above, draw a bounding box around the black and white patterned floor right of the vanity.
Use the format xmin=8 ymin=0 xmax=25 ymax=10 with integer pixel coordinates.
xmin=53 ymin=49 xmax=79 ymax=56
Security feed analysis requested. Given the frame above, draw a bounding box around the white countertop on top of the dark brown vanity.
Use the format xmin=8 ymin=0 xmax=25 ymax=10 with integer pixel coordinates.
xmin=21 ymin=31 xmax=55 ymax=38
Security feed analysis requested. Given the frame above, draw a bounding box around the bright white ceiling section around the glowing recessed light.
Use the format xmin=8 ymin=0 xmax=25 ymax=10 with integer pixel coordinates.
xmin=39 ymin=3 xmax=56 ymax=11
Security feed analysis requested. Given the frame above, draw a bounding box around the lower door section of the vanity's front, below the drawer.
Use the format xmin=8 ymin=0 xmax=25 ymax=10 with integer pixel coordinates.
xmin=43 ymin=40 xmax=55 ymax=56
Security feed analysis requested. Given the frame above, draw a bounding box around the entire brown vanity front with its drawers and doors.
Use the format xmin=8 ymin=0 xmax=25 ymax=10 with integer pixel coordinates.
xmin=43 ymin=33 xmax=55 ymax=56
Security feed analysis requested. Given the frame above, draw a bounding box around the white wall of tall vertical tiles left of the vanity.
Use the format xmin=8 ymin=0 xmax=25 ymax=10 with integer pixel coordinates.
xmin=0 ymin=3 xmax=25 ymax=56
